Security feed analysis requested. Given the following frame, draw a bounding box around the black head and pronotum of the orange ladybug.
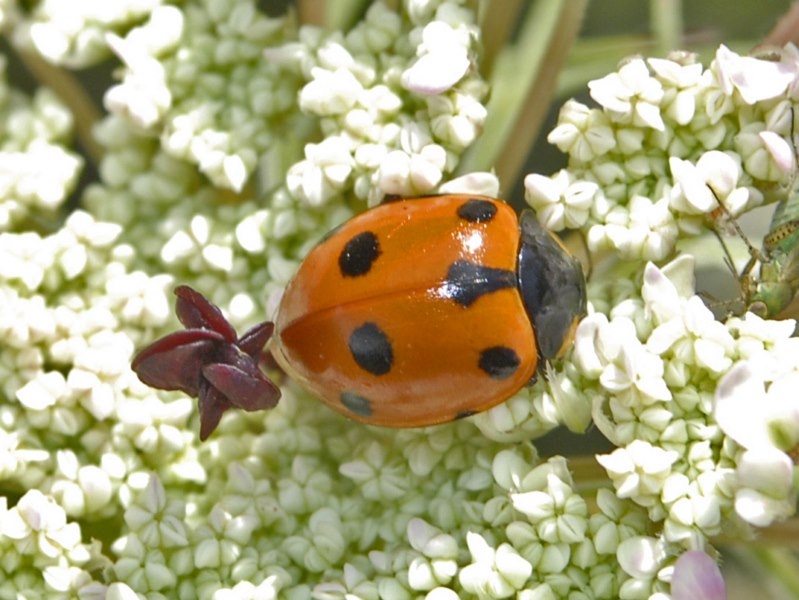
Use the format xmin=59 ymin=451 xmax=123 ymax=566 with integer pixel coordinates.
xmin=517 ymin=210 xmax=586 ymax=361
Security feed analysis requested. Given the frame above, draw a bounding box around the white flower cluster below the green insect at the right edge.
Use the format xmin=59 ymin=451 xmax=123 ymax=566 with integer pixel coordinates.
xmin=574 ymin=255 xmax=799 ymax=585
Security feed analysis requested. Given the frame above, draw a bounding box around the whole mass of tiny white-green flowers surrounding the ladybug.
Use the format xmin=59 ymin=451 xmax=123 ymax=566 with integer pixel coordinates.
xmin=0 ymin=0 xmax=799 ymax=600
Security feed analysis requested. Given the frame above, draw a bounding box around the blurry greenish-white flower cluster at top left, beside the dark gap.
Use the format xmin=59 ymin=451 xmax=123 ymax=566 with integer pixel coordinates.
xmin=105 ymin=0 xmax=299 ymax=192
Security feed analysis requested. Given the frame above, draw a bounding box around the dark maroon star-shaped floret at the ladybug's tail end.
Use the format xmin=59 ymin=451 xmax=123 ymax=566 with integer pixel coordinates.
xmin=131 ymin=285 xmax=280 ymax=441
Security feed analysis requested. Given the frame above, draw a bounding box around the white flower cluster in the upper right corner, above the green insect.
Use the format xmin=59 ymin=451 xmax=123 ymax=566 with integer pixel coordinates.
xmin=525 ymin=46 xmax=799 ymax=260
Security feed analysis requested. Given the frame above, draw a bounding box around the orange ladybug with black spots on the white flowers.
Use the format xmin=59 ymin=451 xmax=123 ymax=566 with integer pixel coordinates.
xmin=270 ymin=194 xmax=586 ymax=427
